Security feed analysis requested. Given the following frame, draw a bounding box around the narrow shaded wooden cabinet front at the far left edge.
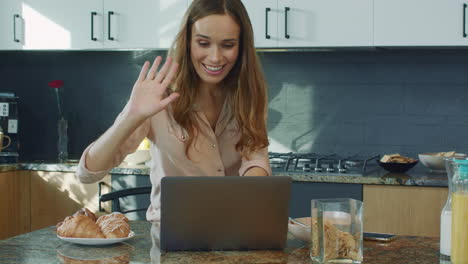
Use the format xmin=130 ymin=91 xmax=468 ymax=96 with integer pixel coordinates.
xmin=0 ymin=171 xmax=31 ymax=239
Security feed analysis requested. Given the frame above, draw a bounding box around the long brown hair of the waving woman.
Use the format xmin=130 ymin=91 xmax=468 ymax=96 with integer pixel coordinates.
xmin=169 ymin=0 xmax=268 ymax=158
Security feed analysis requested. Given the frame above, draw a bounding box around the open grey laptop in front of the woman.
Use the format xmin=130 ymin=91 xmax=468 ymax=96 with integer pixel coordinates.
xmin=160 ymin=176 xmax=291 ymax=251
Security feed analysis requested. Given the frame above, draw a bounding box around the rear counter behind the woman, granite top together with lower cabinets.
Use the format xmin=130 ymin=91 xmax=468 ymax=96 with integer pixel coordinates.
xmin=0 ymin=162 xmax=448 ymax=239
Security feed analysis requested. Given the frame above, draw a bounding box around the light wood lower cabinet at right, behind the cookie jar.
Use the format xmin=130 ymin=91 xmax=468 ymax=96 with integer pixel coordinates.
xmin=363 ymin=185 xmax=448 ymax=237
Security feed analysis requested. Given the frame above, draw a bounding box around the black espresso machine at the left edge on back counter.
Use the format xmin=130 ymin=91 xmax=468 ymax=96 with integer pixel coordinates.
xmin=0 ymin=93 xmax=19 ymax=164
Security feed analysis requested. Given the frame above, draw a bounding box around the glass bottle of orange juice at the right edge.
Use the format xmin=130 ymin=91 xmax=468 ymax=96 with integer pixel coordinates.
xmin=450 ymin=159 xmax=468 ymax=264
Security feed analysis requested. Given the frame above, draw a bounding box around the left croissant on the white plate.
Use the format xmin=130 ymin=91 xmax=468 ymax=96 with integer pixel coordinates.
xmin=57 ymin=214 xmax=105 ymax=238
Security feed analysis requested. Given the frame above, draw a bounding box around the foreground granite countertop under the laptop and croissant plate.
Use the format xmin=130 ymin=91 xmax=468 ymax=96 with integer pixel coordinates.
xmin=0 ymin=221 xmax=450 ymax=264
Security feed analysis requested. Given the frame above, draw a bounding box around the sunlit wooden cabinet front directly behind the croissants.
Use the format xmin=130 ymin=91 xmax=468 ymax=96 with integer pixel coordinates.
xmin=30 ymin=171 xmax=110 ymax=231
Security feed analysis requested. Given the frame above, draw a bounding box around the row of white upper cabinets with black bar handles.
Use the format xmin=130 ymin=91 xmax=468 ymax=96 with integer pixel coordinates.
xmin=0 ymin=0 xmax=468 ymax=50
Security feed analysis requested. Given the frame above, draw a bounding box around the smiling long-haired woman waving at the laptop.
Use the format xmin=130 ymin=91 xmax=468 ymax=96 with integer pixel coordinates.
xmin=77 ymin=0 xmax=271 ymax=221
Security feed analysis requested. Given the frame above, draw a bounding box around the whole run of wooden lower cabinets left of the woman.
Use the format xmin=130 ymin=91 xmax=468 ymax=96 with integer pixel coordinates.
xmin=0 ymin=171 xmax=111 ymax=239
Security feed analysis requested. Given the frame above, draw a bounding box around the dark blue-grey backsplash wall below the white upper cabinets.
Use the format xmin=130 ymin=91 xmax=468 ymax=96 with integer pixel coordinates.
xmin=0 ymin=50 xmax=468 ymax=161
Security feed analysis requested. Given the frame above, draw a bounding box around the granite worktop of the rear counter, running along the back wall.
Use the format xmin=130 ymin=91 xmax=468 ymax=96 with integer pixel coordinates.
xmin=0 ymin=162 xmax=447 ymax=187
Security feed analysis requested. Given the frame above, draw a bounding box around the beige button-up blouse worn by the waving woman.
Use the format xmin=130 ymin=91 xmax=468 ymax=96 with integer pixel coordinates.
xmin=76 ymin=102 xmax=272 ymax=221
